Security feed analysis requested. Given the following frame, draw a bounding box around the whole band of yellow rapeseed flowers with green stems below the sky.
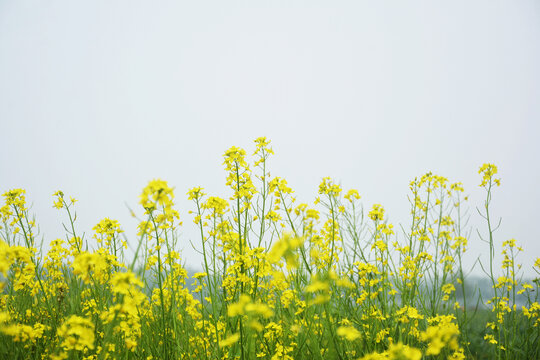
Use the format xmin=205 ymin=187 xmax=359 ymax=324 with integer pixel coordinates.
xmin=0 ymin=142 xmax=540 ymax=360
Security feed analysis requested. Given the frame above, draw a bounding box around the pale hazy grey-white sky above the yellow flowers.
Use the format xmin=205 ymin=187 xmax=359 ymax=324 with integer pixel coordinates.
xmin=0 ymin=0 xmax=540 ymax=275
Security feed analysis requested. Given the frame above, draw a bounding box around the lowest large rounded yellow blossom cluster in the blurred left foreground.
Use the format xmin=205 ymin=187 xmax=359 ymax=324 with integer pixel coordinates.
xmin=58 ymin=315 xmax=94 ymax=351
